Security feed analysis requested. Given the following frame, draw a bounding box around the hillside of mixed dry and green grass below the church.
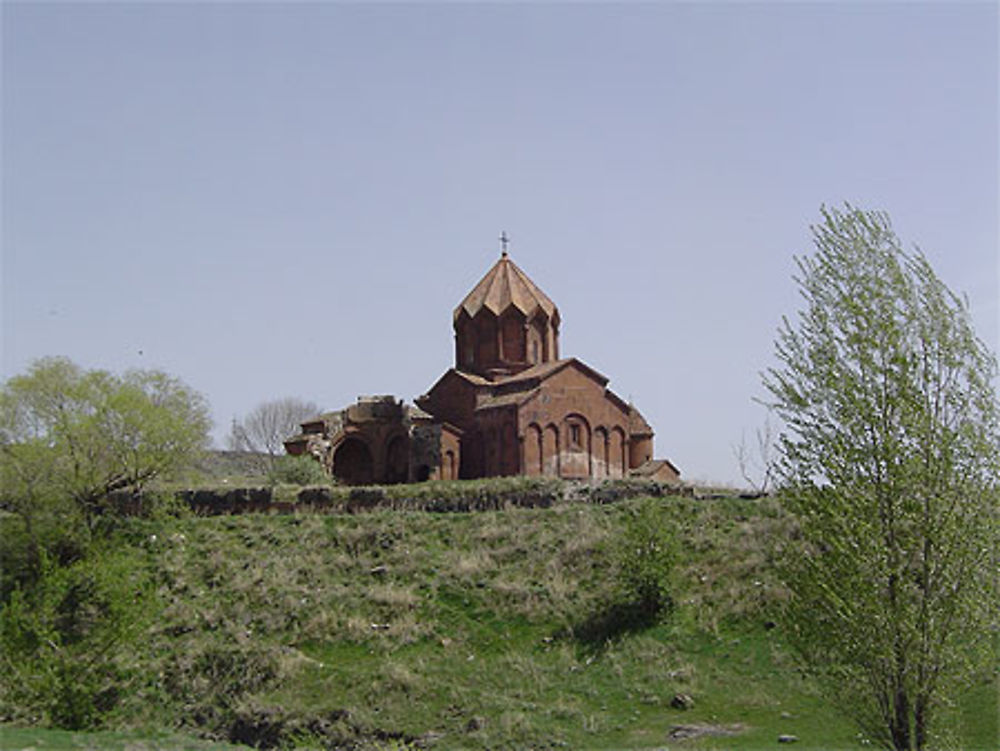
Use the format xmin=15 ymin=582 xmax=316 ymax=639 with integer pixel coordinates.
xmin=0 ymin=488 xmax=998 ymax=749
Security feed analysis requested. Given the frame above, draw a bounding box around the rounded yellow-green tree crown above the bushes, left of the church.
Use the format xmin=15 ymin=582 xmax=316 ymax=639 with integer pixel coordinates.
xmin=0 ymin=358 xmax=211 ymax=536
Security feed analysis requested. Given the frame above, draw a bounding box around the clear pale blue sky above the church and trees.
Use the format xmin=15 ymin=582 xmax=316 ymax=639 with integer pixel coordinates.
xmin=2 ymin=2 xmax=1000 ymax=481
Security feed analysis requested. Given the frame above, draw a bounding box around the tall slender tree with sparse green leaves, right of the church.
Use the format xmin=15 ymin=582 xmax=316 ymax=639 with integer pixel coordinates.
xmin=764 ymin=206 xmax=1000 ymax=750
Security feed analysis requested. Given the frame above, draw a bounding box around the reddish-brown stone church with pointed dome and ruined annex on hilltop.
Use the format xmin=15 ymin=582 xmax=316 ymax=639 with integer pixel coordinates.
xmin=285 ymin=244 xmax=680 ymax=485
